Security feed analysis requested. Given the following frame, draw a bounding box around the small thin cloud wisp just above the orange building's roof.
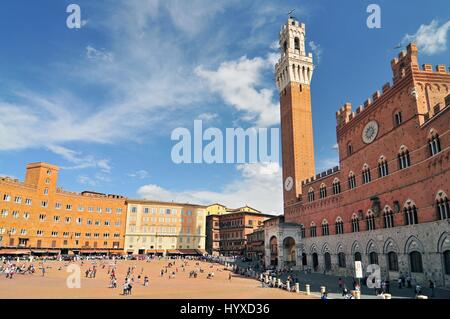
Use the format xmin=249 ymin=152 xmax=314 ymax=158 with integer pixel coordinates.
xmin=48 ymin=145 xmax=111 ymax=173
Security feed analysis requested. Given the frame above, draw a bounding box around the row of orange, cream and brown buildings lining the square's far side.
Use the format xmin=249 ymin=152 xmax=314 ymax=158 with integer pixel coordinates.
xmin=0 ymin=163 xmax=270 ymax=255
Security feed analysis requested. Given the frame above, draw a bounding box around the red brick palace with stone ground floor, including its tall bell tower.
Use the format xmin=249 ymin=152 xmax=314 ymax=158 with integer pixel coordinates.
xmin=265 ymin=18 xmax=450 ymax=286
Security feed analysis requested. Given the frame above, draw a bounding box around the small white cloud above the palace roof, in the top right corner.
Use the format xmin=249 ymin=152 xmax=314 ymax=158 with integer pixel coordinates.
xmin=402 ymin=20 xmax=450 ymax=55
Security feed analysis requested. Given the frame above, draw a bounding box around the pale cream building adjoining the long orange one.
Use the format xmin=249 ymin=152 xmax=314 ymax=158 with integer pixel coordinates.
xmin=125 ymin=200 xmax=206 ymax=255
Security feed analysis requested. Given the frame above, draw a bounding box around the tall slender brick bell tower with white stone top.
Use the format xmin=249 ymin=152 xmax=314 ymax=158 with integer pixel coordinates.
xmin=275 ymin=17 xmax=315 ymax=207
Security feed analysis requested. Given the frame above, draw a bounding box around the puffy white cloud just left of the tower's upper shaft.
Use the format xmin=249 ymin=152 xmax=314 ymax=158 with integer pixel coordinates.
xmin=195 ymin=55 xmax=280 ymax=127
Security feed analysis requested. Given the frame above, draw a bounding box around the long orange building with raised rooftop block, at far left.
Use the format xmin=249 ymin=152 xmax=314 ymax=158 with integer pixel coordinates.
xmin=0 ymin=163 xmax=127 ymax=254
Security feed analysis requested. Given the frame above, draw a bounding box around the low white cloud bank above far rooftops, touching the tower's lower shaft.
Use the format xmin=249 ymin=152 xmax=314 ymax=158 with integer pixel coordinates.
xmin=138 ymin=163 xmax=283 ymax=214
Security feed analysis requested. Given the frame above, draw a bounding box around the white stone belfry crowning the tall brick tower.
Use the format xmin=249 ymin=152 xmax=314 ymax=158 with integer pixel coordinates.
xmin=275 ymin=17 xmax=314 ymax=92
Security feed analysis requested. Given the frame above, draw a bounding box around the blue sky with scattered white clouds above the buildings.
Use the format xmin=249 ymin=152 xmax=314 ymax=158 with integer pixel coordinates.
xmin=0 ymin=0 xmax=450 ymax=213
